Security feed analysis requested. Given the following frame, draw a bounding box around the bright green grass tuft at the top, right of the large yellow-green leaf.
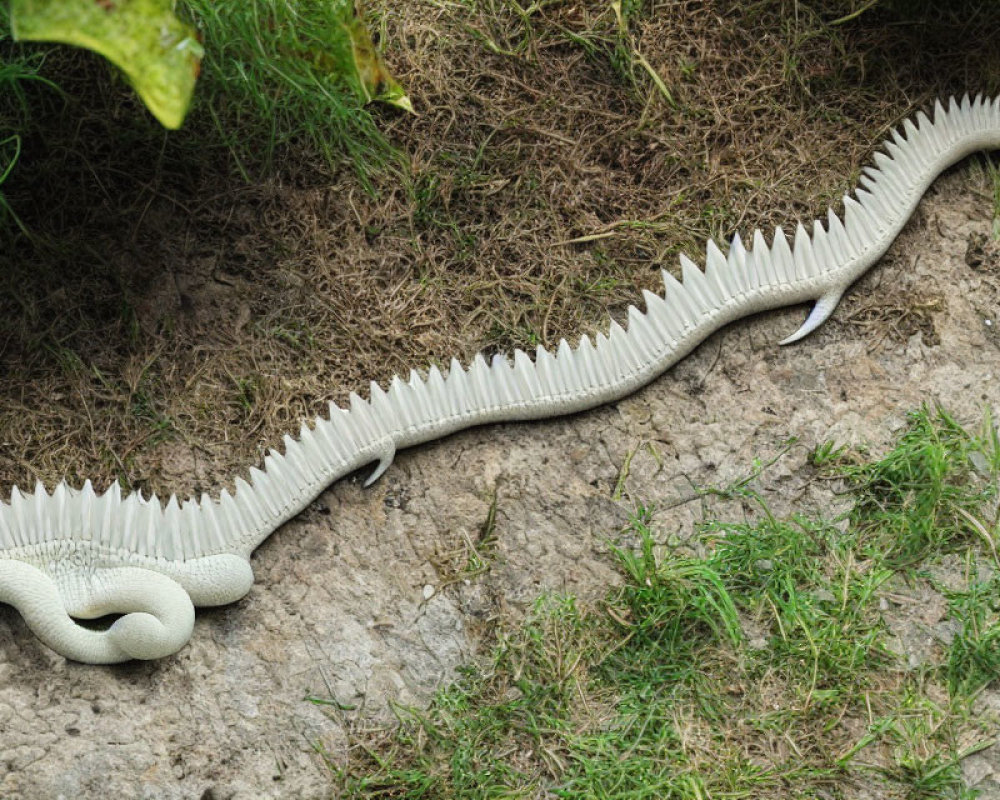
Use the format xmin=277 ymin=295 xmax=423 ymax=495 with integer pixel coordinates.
xmin=174 ymin=0 xmax=398 ymax=184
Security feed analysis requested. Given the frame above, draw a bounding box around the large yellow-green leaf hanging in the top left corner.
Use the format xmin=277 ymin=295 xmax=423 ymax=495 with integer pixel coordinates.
xmin=10 ymin=0 xmax=203 ymax=128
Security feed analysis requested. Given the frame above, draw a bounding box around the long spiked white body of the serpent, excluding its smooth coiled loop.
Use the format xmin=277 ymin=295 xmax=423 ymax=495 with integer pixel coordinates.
xmin=0 ymin=96 xmax=1000 ymax=564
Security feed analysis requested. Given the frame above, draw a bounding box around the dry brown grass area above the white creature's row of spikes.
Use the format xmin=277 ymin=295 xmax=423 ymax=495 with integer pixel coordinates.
xmin=0 ymin=0 xmax=1000 ymax=495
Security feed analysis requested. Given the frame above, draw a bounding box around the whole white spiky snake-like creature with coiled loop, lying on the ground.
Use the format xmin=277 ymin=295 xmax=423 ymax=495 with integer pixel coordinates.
xmin=0 ymin=97 xmax=1000 ymax=664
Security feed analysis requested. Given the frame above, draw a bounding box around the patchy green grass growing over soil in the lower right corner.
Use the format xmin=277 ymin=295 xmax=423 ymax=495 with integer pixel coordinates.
xmin=331 ymin=409 xmax=1000 ymax=800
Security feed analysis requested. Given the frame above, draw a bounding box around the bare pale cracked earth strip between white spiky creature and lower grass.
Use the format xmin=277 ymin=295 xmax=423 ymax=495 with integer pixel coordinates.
xmin=0 ymin=165 xmax=1000 ymax=799
